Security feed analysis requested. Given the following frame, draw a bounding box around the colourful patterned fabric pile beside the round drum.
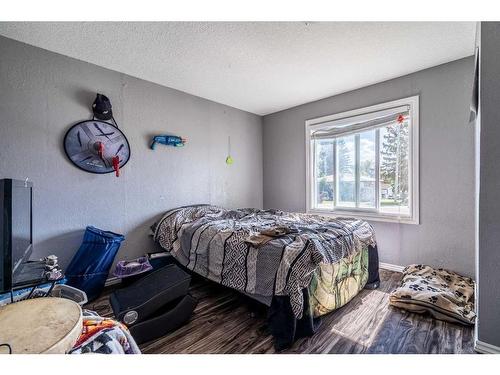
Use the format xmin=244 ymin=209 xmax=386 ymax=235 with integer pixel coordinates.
xmin=69 ymin=310 xmax=141 ymax=354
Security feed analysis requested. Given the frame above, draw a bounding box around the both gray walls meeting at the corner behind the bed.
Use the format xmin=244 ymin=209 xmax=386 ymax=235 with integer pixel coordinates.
xmin=0 ymin=37 xmax=474 ymax=288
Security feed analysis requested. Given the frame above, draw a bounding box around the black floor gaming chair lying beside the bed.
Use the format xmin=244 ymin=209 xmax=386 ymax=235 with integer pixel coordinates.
xmin=109 ymin=264 xmax=197 ymax=343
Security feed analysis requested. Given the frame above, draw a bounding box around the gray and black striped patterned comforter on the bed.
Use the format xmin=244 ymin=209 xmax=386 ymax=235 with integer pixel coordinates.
xmin=154 ymin=205 xmax=375 ymax=318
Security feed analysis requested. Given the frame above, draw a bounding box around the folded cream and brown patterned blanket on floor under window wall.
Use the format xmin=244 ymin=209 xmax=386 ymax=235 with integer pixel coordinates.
xmin=389 ymin=264 xmax=476 ymax=324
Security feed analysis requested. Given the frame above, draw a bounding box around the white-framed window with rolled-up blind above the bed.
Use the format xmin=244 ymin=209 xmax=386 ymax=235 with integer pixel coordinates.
xmin=306 ymin=96 xmax=419 ymax=224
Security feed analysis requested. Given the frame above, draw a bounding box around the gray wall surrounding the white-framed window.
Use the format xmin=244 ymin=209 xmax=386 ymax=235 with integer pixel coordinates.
xmin=263 ymin=57 xmax=474 ymax=275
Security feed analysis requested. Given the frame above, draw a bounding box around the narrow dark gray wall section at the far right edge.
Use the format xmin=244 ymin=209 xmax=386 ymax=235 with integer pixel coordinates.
xmin=477 ymin=22 xmax=500 ymax=347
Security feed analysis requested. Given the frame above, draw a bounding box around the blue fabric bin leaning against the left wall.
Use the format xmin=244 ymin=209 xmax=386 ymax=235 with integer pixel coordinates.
xmin=66 ymin=227 xmax=125 ymax=301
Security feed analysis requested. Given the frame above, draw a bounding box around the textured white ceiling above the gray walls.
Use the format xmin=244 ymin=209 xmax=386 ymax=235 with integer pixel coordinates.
xmin=0 ymin=22 xmax=475 ymax=115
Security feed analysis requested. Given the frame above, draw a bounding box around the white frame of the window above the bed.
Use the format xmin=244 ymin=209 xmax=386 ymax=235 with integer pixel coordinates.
xmin=305 ymin=95 xmax=420 ymax=224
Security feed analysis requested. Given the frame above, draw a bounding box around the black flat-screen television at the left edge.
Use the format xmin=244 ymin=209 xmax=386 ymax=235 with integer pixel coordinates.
xmin=0 ymin=179 xmax=33 ymax=293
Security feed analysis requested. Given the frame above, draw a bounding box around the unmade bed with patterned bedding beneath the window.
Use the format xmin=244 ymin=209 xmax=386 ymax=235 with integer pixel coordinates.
xmin=152 ymin=205 xmax=379 ymax=350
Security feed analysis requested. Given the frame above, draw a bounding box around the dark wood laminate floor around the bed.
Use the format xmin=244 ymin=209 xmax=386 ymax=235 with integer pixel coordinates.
xmin=86 ymin=270 xmax=474 ymax=354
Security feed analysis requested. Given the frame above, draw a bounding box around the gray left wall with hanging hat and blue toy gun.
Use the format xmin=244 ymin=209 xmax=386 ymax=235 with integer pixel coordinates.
xmin=0 ymin=37 xmax=262 ymax=265
